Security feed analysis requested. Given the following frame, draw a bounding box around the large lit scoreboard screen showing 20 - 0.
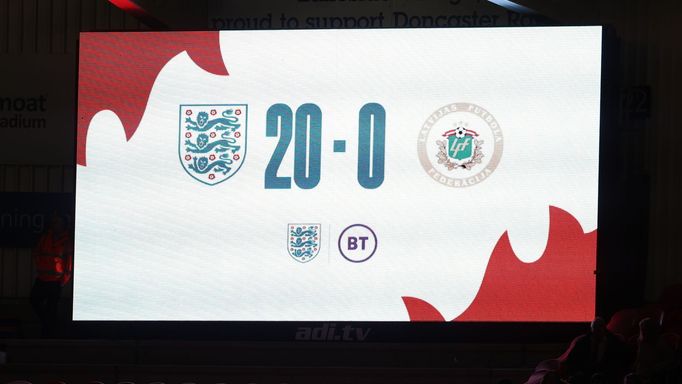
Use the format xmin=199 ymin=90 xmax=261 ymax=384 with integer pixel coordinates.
xmin=73 ymin=27 xmax=602 ymax=322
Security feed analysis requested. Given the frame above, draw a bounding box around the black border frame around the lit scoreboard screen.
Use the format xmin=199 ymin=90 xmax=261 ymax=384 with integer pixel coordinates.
xmin=67 ymin=24 xmax=619 ymax=343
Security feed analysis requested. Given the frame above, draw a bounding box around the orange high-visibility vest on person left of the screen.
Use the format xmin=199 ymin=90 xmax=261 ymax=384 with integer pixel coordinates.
xmin=33 ymin=231 xmax=73 ymax=284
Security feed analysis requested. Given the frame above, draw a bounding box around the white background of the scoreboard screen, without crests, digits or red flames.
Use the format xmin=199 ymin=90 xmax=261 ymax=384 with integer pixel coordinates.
xmin=73 ymin=27 xmax=601 ymax=321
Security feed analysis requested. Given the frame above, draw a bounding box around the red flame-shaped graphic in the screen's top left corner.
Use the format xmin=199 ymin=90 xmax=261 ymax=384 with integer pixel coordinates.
xmin=76 ymin=31 xmax=228 ymax=165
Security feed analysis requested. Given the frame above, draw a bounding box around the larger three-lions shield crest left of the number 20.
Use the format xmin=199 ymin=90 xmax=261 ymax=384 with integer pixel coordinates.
xmin=178 ymin=104 xmax=247 ymax=185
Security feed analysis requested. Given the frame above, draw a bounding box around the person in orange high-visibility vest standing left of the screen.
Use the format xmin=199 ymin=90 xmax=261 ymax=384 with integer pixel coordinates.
xmin=31 ymin=214 xmax=73 ymax=337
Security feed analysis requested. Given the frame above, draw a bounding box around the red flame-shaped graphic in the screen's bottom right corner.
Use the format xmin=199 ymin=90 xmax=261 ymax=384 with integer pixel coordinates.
xmin=403 ymin=206 xmax=597 ymax=322
